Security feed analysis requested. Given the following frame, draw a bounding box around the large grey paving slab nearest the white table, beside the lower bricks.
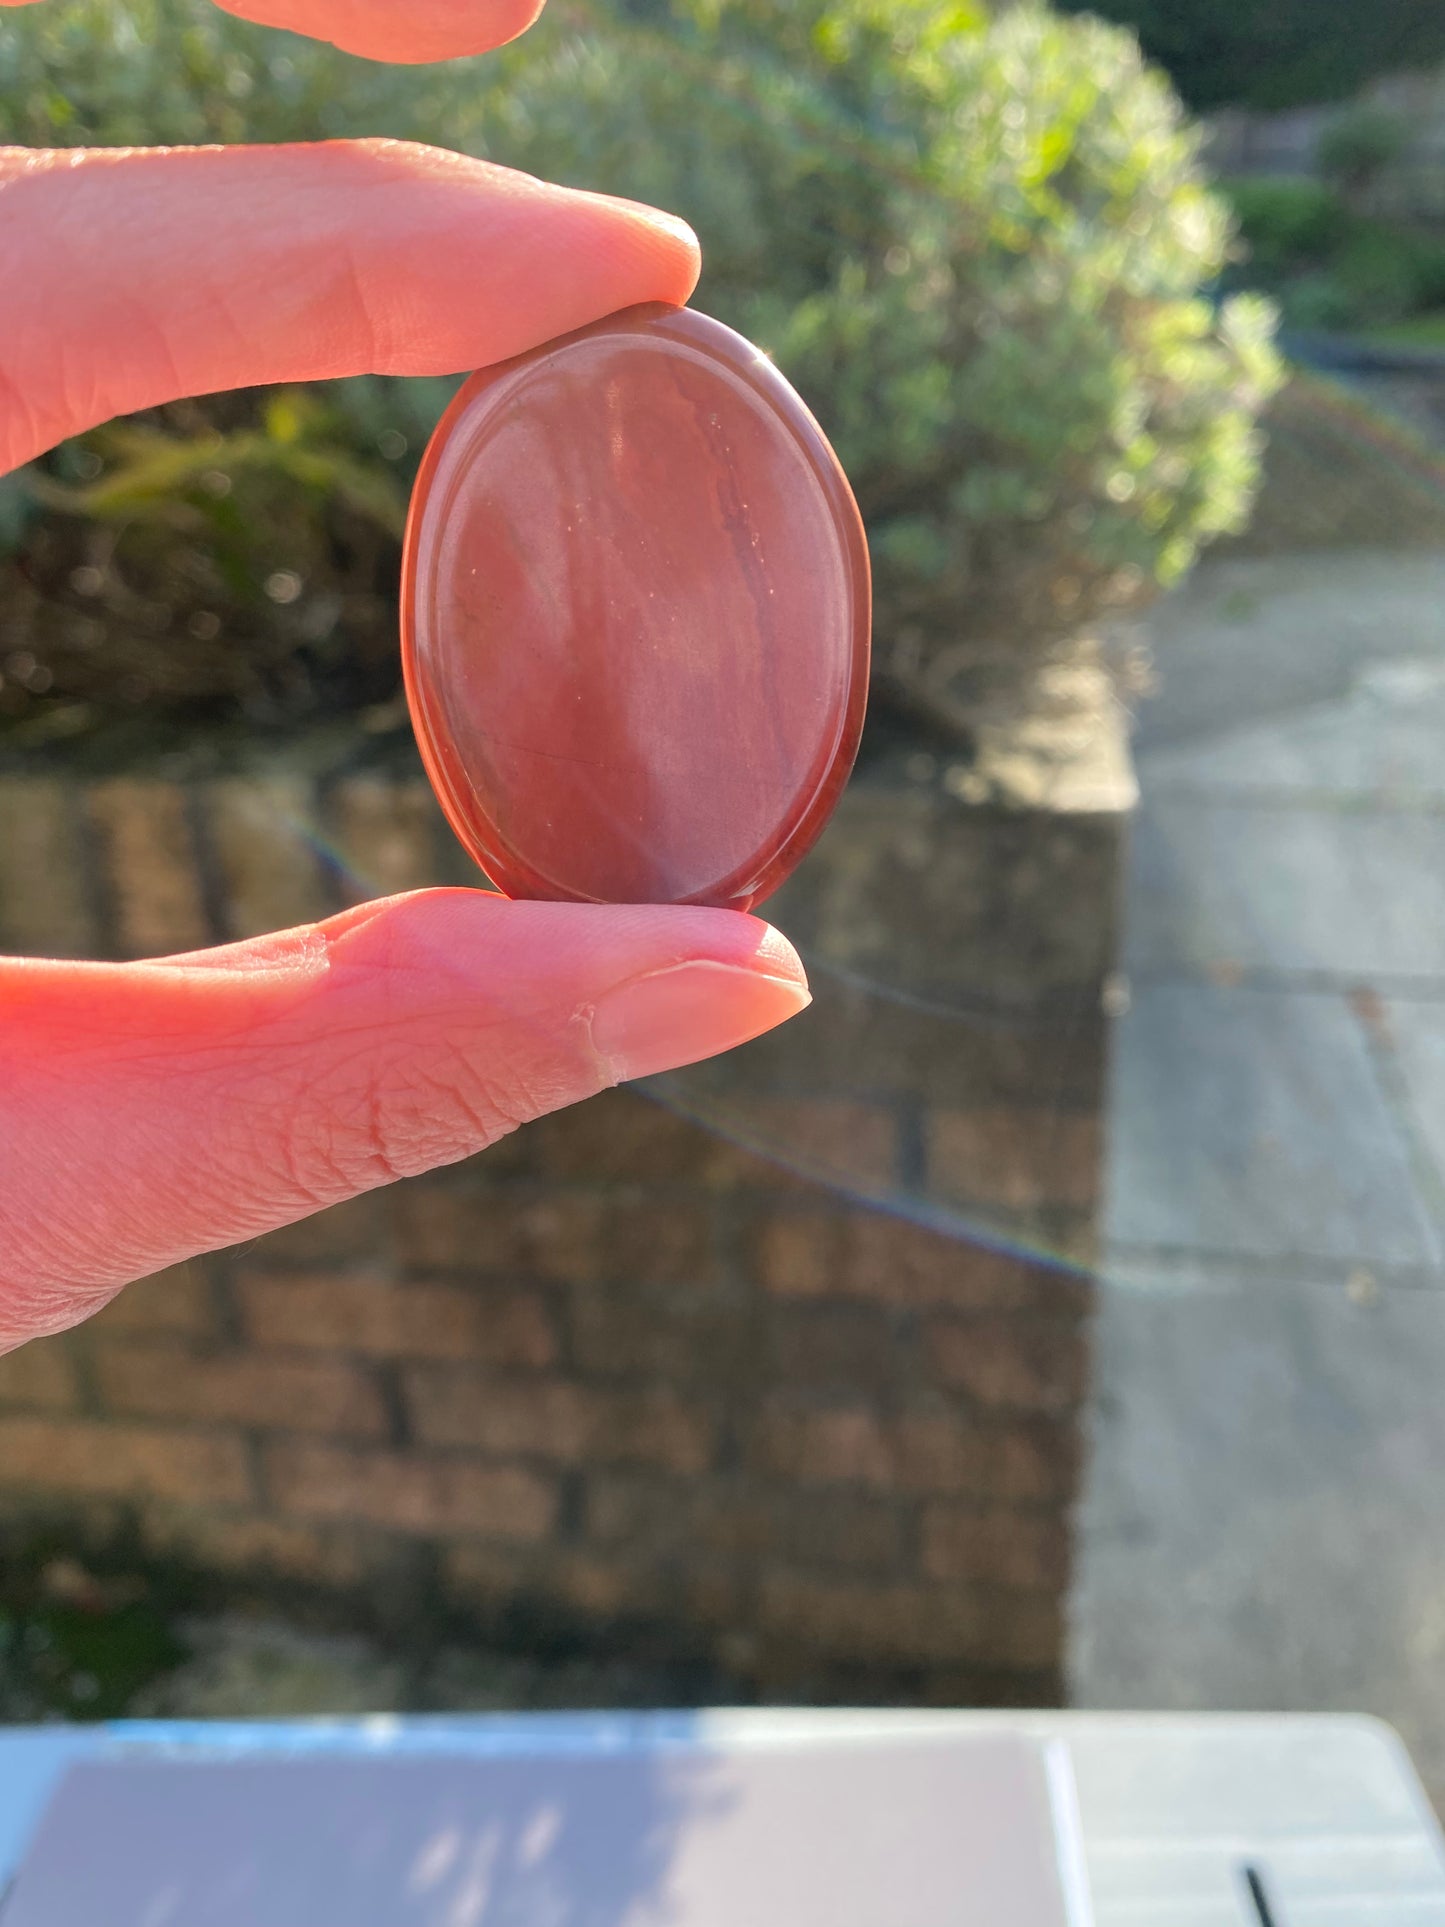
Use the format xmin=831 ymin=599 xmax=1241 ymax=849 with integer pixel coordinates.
xmin=1071 ymin=1285 xmax=1445 ymax=1804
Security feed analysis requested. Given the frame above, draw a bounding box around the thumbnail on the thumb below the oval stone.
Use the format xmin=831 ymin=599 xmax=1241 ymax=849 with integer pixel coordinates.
xmin=591 ymin=964 xmax=813 ymax=1083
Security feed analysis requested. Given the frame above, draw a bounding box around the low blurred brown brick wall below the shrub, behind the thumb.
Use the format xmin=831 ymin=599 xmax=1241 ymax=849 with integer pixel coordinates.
xmin=0 ymin=743 xmax=1123 ymax=1700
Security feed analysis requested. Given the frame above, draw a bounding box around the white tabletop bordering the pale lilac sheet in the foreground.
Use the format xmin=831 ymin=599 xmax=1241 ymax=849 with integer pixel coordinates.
xmin=0 ymin=1711 xmax=1445 ymax=1927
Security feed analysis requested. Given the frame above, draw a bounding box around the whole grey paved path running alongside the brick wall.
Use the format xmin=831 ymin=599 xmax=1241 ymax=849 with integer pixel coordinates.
xmin=1071 ymin=539 xmax=1445 ymax=1804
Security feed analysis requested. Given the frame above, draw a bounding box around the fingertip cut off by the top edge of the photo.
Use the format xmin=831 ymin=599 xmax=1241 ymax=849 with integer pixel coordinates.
xmin=0 ymin=0 xmax=545 ymax=62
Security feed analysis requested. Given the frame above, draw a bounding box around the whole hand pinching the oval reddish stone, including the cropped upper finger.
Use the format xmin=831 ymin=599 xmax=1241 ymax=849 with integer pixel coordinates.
xmin=0 ymin=0 xmax=807 ymax=1351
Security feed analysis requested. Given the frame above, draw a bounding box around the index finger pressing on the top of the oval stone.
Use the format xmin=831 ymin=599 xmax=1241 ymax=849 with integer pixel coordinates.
xmin=0 ymin=141 xmax=697 ymax=474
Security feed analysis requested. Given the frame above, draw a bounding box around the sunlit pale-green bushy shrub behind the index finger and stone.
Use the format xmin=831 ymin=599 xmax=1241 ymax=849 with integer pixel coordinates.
xmin=0 ymin=0 xmax=1277 ymax=743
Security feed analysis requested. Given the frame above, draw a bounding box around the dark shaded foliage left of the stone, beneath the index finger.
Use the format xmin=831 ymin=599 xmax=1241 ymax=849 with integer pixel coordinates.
xmin=0 ymin=389 xmax=418 ymax=736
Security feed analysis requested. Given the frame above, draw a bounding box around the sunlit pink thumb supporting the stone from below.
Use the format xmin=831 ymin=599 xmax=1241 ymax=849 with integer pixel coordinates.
xmin=0 ymin=890 xmax=809 ymax=1351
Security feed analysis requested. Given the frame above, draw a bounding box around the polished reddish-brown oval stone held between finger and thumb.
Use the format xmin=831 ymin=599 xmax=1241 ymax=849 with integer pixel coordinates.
xmin=403 ymin=304 xmax=869 ymax=910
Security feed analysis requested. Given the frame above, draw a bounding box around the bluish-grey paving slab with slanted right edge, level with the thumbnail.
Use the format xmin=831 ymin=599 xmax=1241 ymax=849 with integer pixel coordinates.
xmin=1106 ymin=983 xmax=1441 ymax=1268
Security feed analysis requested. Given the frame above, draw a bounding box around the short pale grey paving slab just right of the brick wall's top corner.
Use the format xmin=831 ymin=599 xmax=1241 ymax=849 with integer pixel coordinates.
xmin=1125 ymin=790 xmax=1445 ymax=981
